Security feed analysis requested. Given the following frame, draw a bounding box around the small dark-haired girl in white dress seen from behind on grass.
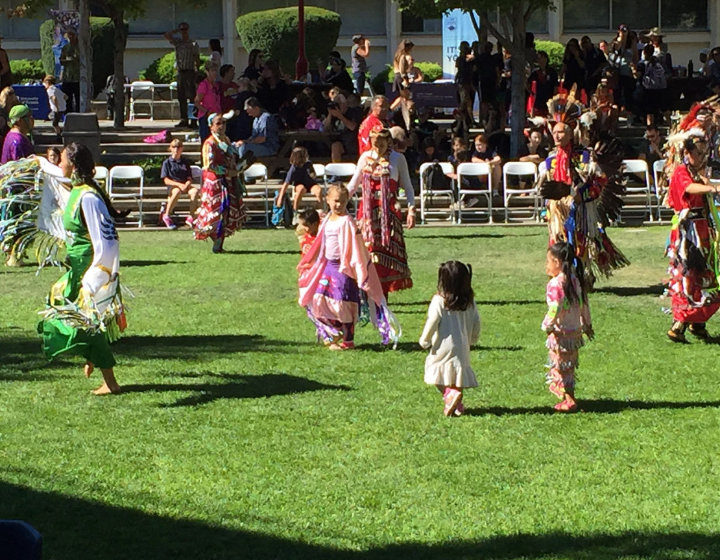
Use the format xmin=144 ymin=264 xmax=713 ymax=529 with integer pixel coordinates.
xmin=420 ymin=261 xmax=480 ymax=416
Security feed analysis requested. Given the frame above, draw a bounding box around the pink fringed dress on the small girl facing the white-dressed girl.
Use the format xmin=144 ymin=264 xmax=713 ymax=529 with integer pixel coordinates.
xmin=541 ymin=273 xmax=591 ymax=399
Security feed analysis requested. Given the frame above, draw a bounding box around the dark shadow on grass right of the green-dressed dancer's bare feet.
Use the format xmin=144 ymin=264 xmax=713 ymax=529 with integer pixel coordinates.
xmin=122 ymin=373 xmax=351 ymax=407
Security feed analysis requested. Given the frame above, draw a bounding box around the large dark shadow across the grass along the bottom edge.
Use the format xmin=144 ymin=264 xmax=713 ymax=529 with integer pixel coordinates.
xmin=0 ymin=476 xmax=720 ymax=560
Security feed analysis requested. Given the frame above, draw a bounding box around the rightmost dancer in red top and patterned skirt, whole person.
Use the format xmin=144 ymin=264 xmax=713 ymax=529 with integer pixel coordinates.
xmin=666 ymin=136 xmax=720 ymax=342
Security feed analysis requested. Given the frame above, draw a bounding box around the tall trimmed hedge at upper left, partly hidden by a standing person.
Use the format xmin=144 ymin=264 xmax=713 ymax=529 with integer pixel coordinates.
xmin=40 ymin=17 xmax=127 ymax=95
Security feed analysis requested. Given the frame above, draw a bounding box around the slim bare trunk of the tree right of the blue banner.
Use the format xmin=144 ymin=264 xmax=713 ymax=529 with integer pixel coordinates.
xmin=510 ymin=4 xmax=527 ymax=158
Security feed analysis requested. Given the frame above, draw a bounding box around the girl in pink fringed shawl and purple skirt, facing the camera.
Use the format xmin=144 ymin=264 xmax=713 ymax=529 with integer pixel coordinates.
xmin=298 ymin=185 xmax=400 ymax=350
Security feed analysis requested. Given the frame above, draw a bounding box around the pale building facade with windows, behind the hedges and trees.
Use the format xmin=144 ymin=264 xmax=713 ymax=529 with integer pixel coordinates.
xmin=0 ymin=0 xmax=720 ymax=80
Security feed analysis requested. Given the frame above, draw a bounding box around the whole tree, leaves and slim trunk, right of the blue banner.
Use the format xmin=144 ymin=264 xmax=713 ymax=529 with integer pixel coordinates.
xmin=399 ymin=0 xmax=555 ymax=156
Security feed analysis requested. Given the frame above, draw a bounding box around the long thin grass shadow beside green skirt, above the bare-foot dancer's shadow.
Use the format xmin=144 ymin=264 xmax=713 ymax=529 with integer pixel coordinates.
xmin=113 ymin=334 xmax=315 ymax=359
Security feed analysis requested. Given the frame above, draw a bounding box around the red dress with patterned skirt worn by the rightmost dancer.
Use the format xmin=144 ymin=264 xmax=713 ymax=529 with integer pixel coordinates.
xmin=665 ymin=164 xmax=720 ymax=323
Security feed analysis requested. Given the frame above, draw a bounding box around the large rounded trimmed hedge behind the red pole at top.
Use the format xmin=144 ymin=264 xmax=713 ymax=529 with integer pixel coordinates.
xmin=235 ymin=6 xmax=342 ymax=74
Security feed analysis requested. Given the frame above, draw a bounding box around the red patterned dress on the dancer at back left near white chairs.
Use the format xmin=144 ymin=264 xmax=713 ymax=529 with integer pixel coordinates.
xmin=193 ymin=134 xmax=245 ymax=240
